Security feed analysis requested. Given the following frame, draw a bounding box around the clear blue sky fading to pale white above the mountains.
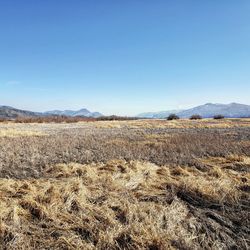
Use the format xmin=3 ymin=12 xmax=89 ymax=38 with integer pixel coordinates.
xmin=0 ymin=0 xmax=250 ymax=115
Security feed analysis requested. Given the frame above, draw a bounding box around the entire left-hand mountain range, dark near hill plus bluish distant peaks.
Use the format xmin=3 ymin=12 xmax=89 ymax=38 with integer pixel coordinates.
xmin=0 ymin=106 xmax=103 ymax=119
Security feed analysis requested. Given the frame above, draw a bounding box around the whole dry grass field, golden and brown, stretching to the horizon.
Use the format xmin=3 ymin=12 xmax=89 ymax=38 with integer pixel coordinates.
xmin=0 ymin=119 xmax=250 ymax=250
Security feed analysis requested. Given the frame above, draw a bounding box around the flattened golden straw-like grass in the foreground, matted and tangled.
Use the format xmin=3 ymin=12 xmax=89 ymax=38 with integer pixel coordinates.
xmin=0 ymin=158 xmax=250 ymax=249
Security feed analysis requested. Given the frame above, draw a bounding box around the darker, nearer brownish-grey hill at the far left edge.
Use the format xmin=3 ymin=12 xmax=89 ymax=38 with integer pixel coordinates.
xmin=0 ymin=106 xmax=41 ymax=119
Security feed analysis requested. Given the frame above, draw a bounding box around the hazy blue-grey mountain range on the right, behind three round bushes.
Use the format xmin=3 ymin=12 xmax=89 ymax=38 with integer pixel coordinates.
xmin=138 ymin=103 xmax=250 ymax=118
